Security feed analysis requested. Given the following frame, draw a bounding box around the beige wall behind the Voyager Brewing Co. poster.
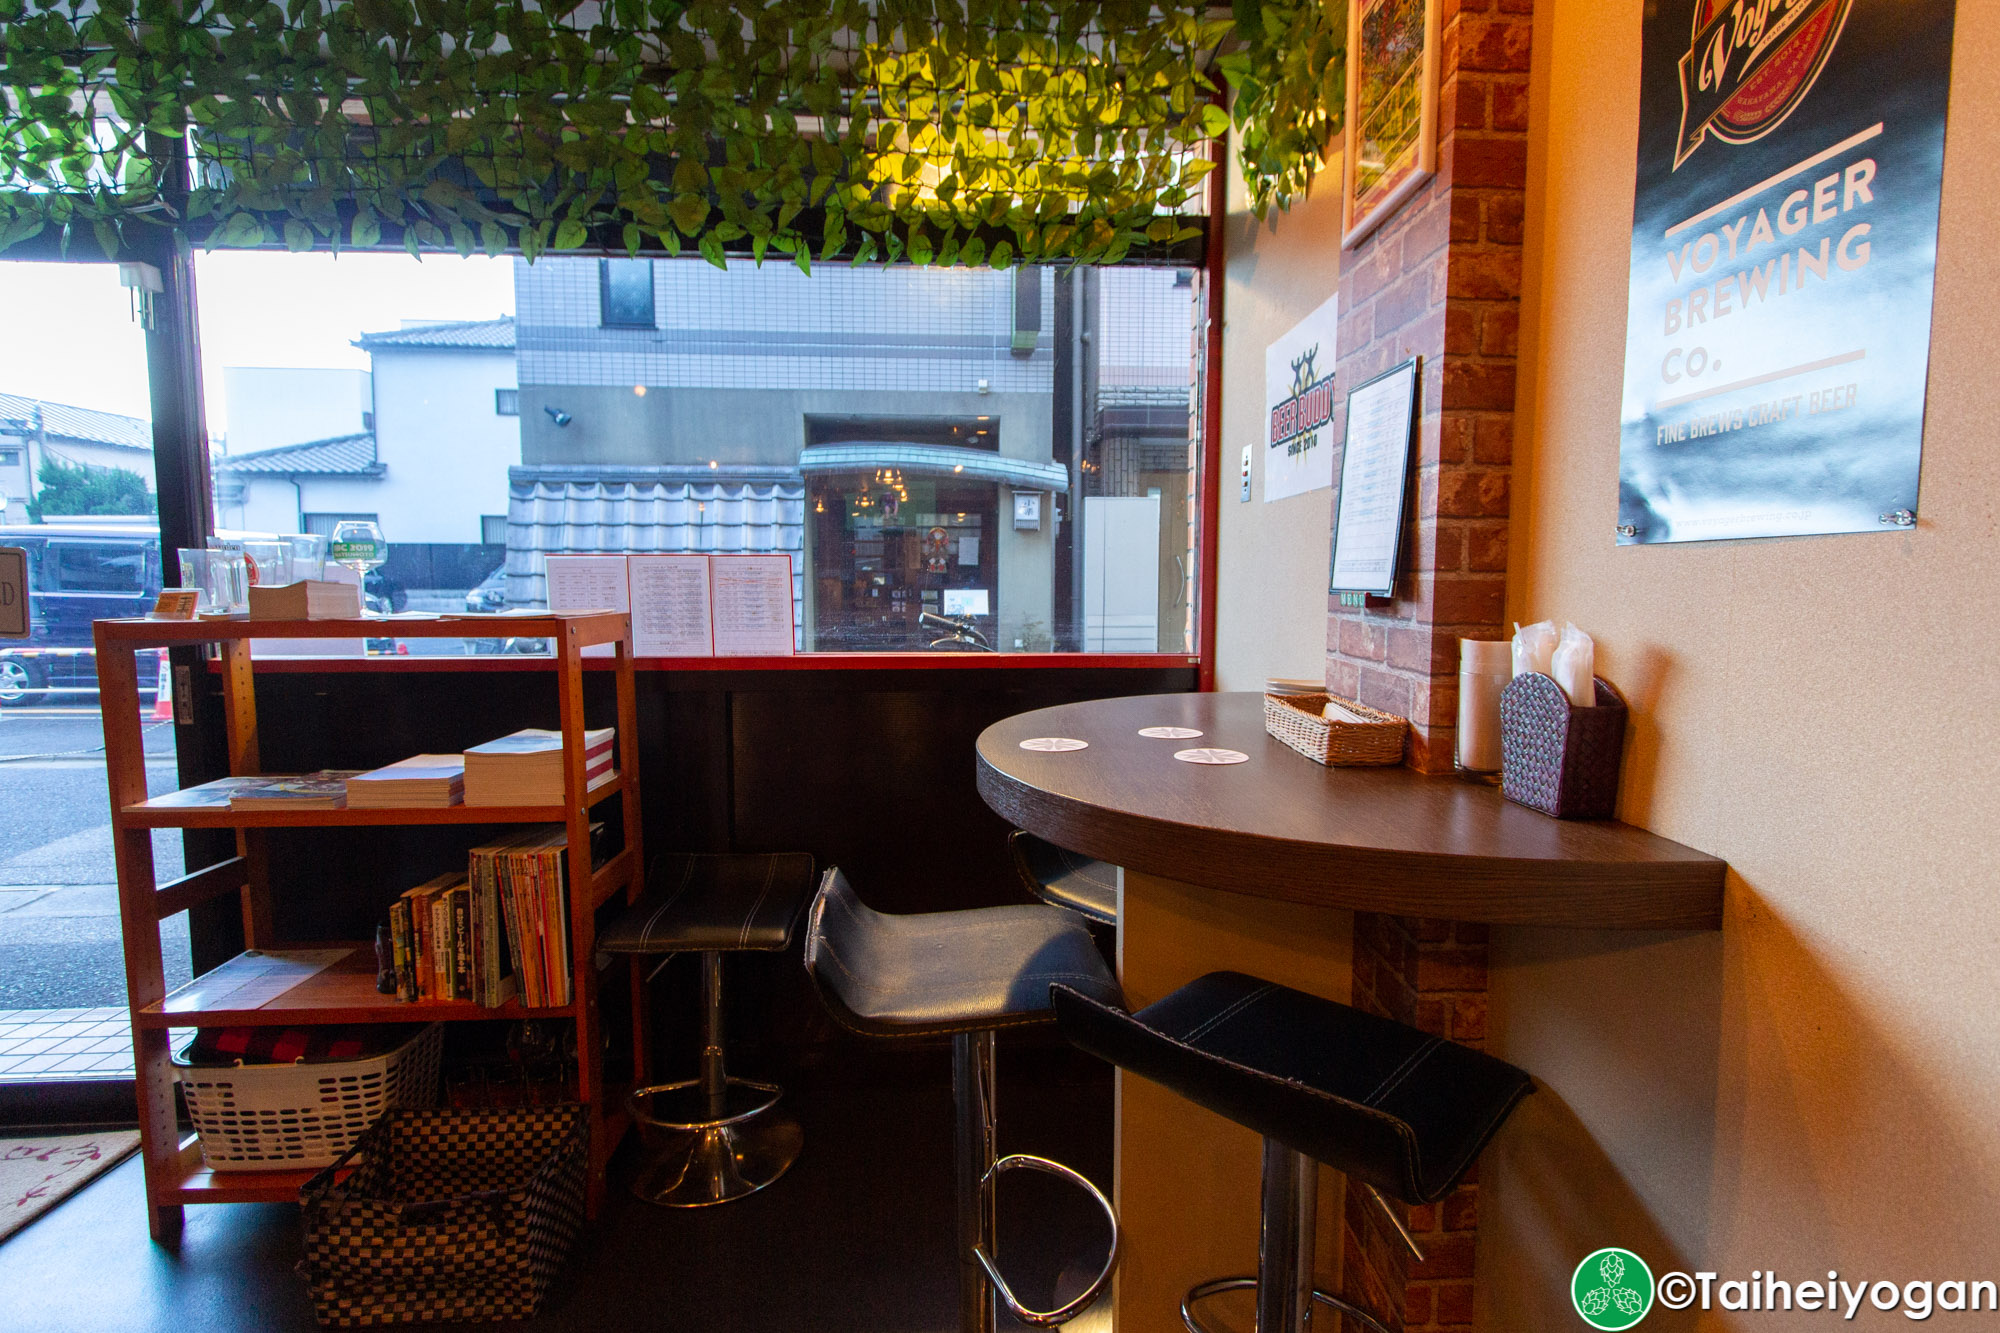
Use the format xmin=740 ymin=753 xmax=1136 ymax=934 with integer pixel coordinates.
xmin=1488 ymin=0 xmax=2000 ymax=1333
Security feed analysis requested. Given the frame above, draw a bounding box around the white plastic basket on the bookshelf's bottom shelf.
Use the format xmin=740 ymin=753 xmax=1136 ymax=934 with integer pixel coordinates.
xmin=174 ymin=1023 xmax=444 ymax=1171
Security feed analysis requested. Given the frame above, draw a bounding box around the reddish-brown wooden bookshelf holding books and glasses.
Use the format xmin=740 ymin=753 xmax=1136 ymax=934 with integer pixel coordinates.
xmin=94 ymin=612 xmax=644 ymax=1239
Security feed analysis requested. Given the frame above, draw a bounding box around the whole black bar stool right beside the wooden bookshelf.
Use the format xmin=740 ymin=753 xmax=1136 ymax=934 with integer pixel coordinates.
xmin=598 ymin=853 xmax=812 ymax=1207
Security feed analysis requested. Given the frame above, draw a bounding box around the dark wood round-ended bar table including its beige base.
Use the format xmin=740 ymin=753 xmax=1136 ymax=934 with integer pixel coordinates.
xmin=978 ymin=695 xmax=1726 ymax=1333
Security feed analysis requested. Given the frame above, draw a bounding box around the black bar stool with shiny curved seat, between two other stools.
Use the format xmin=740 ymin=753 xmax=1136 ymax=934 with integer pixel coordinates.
xmin=806 ymin=869 xmax=1118 ymax=1333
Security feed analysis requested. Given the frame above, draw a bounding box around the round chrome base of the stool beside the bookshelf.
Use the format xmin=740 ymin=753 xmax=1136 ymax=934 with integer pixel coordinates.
xmin=628 ymin=1079 xmax=806 ymax=1209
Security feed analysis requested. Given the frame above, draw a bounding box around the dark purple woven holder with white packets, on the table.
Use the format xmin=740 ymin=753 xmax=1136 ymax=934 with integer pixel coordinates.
xmin=1500 ymin=673 xmax=1626 ymax=819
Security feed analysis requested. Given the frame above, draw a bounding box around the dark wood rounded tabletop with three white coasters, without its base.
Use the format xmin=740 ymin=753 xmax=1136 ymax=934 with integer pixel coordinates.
xmin=978 ymin=695 xmax=1726 ymax=931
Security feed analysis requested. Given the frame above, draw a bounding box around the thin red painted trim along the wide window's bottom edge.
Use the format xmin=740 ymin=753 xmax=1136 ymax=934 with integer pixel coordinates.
xmin=225 ymin=652 xmax=1200 ymax=675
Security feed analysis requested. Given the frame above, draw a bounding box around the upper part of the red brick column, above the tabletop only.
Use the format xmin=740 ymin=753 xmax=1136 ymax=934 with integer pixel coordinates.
xmin=1326 ymin=0 xmax=1532 ymax=773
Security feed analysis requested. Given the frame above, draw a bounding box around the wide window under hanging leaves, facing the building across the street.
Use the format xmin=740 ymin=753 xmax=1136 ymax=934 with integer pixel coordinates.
xmin=196 ymin=252 xmax=1200 ymax=652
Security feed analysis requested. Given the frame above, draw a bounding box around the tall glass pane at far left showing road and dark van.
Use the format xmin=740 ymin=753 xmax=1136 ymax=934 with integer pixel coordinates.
xmin=0 ymin=260 xmax=188 ymax=1083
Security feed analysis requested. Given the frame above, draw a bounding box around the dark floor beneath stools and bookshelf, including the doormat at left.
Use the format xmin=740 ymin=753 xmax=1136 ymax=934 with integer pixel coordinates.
xmin=0 ymin=1041 xmax=1112 ymax=1333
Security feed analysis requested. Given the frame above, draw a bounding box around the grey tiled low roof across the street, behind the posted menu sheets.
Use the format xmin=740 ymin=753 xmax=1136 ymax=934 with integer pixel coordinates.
xmin=506 ymin=464 xmax=806 ymax=638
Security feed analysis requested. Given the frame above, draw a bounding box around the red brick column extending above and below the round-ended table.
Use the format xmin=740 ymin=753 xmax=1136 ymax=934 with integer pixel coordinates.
xmin=1326 ymin=0 xmax=1534 ymax=1333
